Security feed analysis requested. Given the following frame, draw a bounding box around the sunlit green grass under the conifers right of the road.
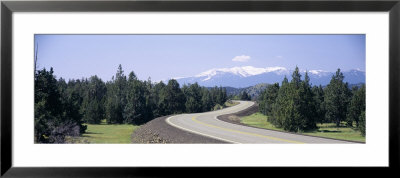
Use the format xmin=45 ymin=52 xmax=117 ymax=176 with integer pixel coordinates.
xmin=240 ymin=113 xmax=365 ymax=142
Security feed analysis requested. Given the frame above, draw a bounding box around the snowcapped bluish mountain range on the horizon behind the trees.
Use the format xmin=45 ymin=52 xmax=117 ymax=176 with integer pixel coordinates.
xmin=175 ymin=66 xmax=365 ymax=88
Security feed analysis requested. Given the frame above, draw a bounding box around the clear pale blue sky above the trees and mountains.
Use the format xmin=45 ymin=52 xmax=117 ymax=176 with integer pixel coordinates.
xmin=35 ymin=35 xmax=365 ymax=81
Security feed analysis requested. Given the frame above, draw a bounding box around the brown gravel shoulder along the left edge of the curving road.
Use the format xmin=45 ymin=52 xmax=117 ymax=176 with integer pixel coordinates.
xmin=131 ymin=115 xmax=227 ymax=143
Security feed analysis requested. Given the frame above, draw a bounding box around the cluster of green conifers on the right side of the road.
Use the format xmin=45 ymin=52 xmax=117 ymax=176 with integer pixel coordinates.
xmin=258 ymin=67 xmax=366 ymax=136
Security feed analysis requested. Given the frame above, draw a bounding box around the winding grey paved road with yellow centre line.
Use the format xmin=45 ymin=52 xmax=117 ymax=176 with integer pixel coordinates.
xmin=166 ymin=101 xmax=353 ymax=144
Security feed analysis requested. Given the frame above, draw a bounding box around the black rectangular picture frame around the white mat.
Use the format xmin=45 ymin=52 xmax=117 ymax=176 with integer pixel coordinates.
xmin=0 ymin=0 xmax=400 ymax=177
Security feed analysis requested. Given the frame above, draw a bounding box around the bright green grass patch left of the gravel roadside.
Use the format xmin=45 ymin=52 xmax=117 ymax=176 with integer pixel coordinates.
xmin=70 ymin=119 xmax=139 ymax=143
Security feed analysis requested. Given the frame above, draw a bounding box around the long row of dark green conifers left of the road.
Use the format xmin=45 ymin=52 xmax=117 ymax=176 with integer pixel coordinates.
xmin=34 ymin=65 xmax=227 ymax=143
